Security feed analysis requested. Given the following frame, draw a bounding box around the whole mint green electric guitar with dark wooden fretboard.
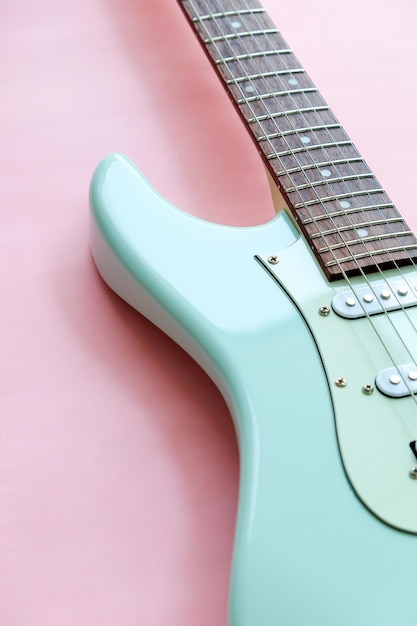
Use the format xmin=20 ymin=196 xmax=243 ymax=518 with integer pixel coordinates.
xmin=91 ymin=0 xmax=417 ymax=626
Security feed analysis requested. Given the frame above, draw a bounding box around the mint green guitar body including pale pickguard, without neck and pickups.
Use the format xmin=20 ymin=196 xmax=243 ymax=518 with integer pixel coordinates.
xmin=91 ymin=155 xmax=417 ymax=626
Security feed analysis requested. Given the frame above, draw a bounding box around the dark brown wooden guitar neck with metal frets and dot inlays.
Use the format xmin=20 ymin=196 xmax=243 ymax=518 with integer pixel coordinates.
xmin=178 ymin=0 xmax=417 ymax=280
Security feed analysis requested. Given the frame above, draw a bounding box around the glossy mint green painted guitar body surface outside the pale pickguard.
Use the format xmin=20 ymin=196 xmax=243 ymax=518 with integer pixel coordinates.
xmin=91 ymin=155 xmax=415 ymax=626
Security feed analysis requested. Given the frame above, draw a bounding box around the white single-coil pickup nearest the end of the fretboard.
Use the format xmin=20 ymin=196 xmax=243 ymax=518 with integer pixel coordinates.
xmin=332 ymin=281 xmax=417 ymax=319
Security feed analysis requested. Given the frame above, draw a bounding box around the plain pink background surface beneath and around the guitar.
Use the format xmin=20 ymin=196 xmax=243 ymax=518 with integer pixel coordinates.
xmin=0 ymin=0 xmax=417 ymax=626
